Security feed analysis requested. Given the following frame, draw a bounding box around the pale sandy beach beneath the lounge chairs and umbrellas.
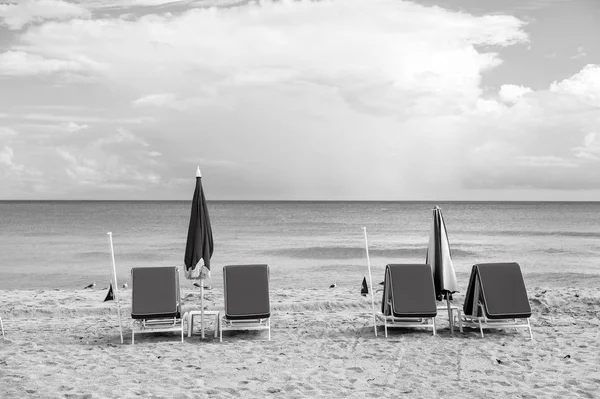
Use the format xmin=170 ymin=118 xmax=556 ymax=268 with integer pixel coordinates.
xmin=0 ymin=274 xmax=600 ymax=398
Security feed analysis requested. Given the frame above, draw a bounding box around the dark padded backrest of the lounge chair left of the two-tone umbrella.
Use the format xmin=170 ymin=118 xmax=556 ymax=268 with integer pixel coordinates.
xmin=382 ymin=264 xmax=437 ymax=317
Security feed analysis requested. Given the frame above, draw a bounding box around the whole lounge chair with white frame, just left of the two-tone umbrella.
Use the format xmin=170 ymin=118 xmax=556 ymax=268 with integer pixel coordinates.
xmin=376 ymin=264 xmax=437 ymax=337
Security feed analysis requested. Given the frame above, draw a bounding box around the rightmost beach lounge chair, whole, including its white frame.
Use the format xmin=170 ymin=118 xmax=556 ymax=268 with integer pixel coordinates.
xmin=462 ymin=263 xmax=533 ymax=339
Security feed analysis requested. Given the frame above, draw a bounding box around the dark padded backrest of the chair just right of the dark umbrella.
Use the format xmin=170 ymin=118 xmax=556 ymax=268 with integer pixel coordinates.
xmin=223 ymin=265 xmax=271 ymax=320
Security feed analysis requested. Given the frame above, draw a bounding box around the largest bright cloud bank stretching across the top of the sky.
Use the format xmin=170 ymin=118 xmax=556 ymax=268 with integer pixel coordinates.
xmin=11 ymin=0 xmax=527 ymax=112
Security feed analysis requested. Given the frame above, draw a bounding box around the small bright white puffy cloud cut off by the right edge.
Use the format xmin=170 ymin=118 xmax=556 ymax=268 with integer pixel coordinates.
xmin=550 ymin=64 xmax=600 ymax=107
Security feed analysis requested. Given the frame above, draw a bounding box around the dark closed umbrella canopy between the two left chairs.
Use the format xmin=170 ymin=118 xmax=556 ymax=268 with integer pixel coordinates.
xmin=185 ymin=168 xmax=214 ymax=279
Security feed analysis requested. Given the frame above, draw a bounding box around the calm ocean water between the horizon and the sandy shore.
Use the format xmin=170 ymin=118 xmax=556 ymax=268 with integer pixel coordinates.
xmin=0 ymin=201 xmax=600 ymax=289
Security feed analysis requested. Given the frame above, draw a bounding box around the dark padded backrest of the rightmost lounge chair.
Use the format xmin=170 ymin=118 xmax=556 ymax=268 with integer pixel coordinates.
xmin=463 ymin=263 xmax=531 ymax=319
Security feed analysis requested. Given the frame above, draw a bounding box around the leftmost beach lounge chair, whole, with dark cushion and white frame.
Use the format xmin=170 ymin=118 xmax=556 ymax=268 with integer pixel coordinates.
xmin=131 ymin=266 xmax=183 ymax=345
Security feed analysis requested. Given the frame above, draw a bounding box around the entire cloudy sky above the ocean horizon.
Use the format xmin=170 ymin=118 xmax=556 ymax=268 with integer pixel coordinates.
xmin=0 ymin=0 xmax=600 ymax=201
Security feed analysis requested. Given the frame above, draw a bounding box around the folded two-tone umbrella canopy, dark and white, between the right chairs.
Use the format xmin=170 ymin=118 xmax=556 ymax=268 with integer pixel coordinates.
xmin=425 ymin=206 xmax=458 ymax=301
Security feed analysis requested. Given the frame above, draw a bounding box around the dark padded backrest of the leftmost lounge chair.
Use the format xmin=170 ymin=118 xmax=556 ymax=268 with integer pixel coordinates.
xmin=131 ymin=266 xmax=181 ymax=319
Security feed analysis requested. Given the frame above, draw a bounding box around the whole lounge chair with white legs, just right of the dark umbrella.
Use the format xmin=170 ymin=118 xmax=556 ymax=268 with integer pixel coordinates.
xmin=219 ymin=265 xmax=271 ymax=341
